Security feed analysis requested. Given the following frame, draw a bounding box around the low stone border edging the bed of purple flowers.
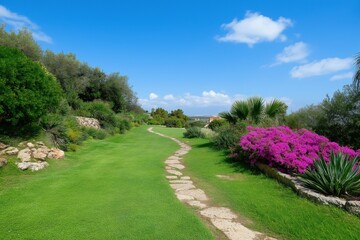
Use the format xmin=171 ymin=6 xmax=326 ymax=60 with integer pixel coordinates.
xmin=255 ymin=163 xmax=360 ymax=217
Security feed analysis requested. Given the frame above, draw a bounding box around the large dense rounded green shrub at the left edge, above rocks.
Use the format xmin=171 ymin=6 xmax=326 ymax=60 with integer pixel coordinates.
xmin=0 ymin=46 xmax=62 ymax=133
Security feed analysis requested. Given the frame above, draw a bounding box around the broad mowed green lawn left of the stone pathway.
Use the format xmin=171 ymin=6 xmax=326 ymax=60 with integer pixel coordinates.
xmin=0 ymin=126 xmax=214 ymax=240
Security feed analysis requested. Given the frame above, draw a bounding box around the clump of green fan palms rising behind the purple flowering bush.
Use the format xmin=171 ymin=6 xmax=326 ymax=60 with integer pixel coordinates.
xmin=220 ymin=97 xmax=287 ymax=124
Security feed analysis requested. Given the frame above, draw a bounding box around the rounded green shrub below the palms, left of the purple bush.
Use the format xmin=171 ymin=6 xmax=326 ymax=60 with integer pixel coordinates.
xmin=212 ymin=126 xmax=241 ymax=150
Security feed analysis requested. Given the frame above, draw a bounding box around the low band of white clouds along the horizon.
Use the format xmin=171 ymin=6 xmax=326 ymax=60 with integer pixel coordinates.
xmin=139 ymin=90 xmax=291 ymax=114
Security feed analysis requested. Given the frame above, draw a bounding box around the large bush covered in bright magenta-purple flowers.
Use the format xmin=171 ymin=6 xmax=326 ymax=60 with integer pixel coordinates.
xmin=240 ymin=126 xmax=360 ymax=173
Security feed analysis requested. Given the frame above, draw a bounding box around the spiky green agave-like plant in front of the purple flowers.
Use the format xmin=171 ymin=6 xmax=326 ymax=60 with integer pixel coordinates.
xmin=300 ymin=153 xmax=360 ymax=197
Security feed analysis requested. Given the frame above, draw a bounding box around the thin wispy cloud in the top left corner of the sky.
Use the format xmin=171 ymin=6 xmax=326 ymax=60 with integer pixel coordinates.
xmin=0 ymin=5 xmax=52 ymax=43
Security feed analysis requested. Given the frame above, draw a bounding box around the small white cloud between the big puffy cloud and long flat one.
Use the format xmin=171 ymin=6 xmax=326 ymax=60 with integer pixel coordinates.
xmin=273 ymin=42 xmax=310 ymax=65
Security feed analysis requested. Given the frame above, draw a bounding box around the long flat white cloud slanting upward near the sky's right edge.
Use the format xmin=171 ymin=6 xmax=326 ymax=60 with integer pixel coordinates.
xmin=290 ymin=58 xmax=353 ymax=78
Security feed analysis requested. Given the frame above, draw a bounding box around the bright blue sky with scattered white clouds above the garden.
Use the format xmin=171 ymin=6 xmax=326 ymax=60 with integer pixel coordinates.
xmin=0 ymin=0 xmax=360 ymax=115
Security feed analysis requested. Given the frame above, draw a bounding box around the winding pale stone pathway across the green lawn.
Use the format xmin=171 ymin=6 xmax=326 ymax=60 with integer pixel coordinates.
xmin=148 ymin=128 xmax=276 ymax=240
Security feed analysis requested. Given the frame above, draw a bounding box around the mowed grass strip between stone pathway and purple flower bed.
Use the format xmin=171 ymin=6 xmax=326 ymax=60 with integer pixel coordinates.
xmin=154 ymin=127 xmax=360 ymax=240
